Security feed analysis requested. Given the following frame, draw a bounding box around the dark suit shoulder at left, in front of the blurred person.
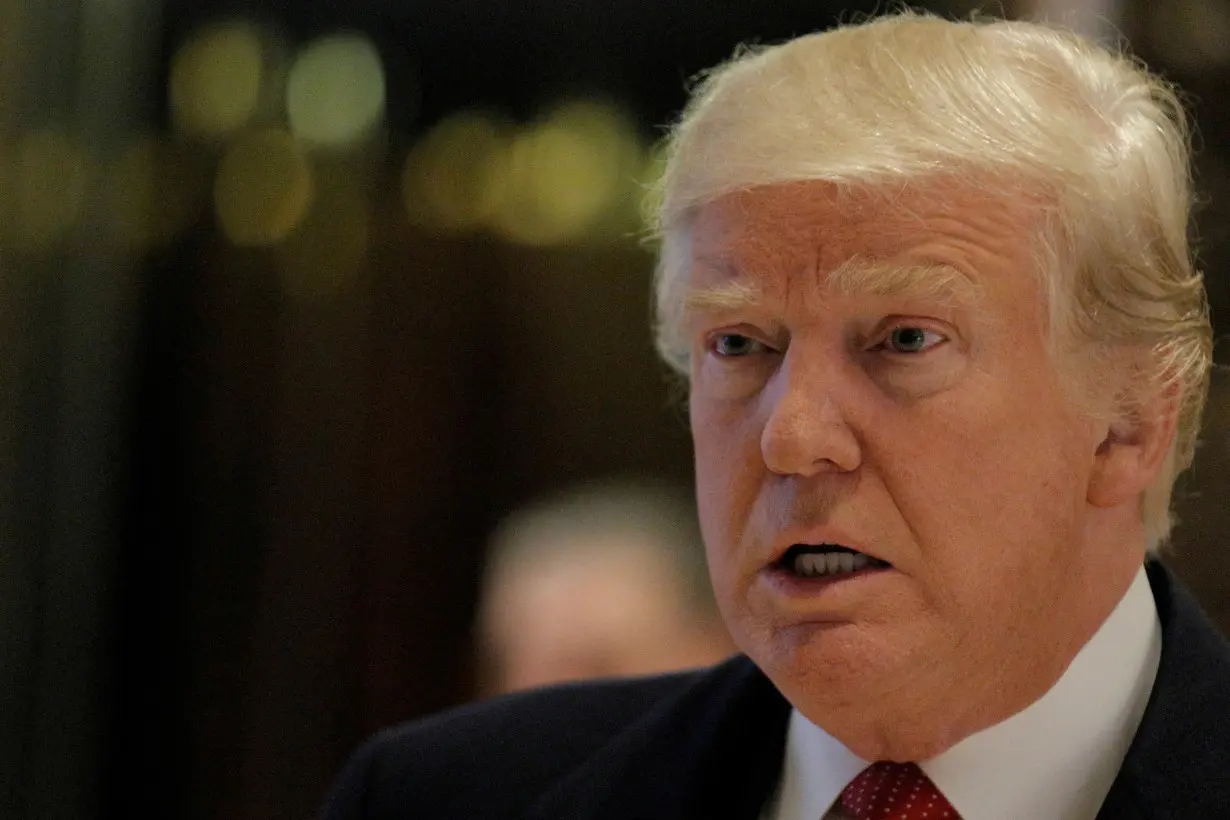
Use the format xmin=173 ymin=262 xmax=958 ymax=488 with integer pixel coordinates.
xmin=325 ymin=666 xmax=722 ymax=820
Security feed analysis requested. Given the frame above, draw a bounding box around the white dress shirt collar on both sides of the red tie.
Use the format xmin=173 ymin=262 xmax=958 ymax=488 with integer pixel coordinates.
xmin=761 ymin=567 xmax=1161 ymax=820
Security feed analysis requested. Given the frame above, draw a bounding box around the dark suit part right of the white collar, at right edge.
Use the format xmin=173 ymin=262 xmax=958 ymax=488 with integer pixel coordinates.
xmin=1097 ymin=561 xmax=1230 ymax=820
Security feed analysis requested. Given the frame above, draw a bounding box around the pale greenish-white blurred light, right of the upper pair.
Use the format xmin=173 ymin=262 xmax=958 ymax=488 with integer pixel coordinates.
xmin=287 ymin=33 xmax=385 ymax=148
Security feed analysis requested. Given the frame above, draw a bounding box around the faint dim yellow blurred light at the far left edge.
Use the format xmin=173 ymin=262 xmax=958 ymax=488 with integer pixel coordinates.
xmin=0 ymin=129 xmax=89 ymax=251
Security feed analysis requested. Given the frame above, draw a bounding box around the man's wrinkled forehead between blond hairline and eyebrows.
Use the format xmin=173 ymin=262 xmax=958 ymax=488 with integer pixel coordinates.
xmin=689 ymin=181 xmax=1042 ymax=307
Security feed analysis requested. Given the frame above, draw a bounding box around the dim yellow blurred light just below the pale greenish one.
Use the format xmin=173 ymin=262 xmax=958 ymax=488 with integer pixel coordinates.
xmin=214 ymin=128 xmax=312 ymax=246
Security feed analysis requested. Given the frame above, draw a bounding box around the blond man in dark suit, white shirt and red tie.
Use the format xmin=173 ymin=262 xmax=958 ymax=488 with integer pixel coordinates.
xmin=319 ymin=15 xmax=1230 ymax=820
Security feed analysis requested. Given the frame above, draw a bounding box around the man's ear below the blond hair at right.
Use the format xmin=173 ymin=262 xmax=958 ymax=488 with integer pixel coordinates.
xmin=1087 ymin=385 xmax=1180 ymax=508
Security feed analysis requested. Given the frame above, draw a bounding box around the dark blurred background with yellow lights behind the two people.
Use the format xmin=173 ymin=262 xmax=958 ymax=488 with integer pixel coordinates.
xmin=0 ymin=0 xmax=1230 ymax=820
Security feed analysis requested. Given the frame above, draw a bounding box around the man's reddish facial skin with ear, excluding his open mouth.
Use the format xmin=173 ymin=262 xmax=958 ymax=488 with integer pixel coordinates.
xmin=686 ymin=182 xmax=1173 ymax=761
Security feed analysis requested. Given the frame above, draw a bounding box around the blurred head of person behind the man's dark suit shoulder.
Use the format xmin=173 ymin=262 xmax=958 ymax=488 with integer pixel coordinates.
xmin=478 ymin=482 xmax=733 ymax=693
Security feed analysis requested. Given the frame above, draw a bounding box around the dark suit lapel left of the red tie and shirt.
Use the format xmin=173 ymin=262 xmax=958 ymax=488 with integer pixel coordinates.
xmin=525 ymin=656 xmax=790 ymax=820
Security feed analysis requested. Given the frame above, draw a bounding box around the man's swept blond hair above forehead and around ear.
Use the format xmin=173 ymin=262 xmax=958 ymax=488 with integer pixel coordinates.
xmin=654 ymin=12 xmax=1212 ymax=546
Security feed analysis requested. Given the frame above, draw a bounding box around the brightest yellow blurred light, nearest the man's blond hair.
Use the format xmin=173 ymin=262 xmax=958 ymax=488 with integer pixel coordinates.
xmin=493 ymin=101 xmax=641 ymax=246
